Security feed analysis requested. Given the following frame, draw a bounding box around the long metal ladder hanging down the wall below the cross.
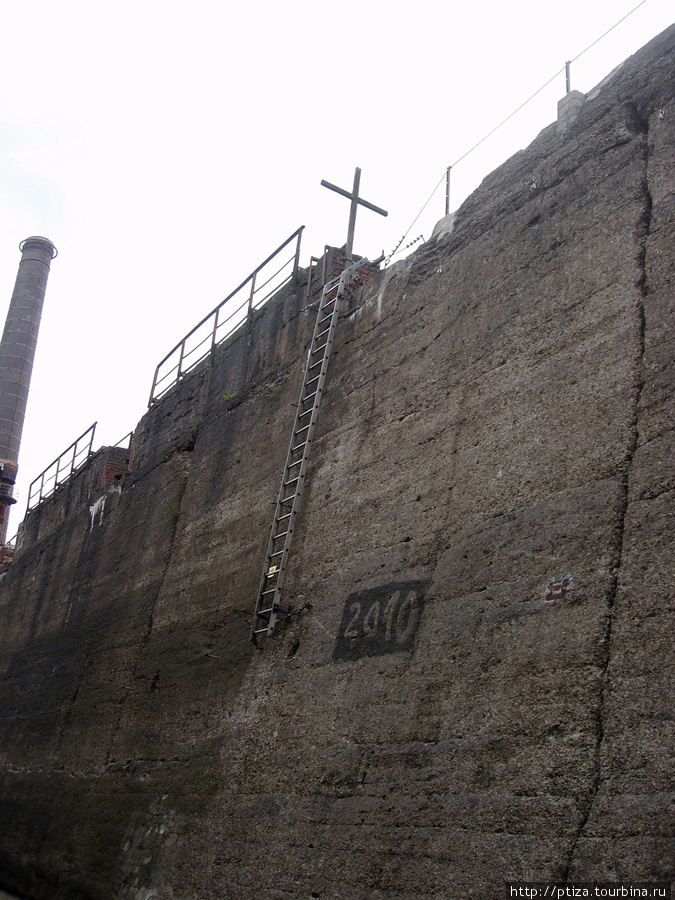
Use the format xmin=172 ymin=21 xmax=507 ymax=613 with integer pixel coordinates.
xmin=251 ymin=259 xmax=368 ymax=644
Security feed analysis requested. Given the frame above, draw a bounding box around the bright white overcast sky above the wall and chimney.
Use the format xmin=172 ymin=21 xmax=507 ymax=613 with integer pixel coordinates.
xmin=0 ymin=0 xmax=675 ymax=535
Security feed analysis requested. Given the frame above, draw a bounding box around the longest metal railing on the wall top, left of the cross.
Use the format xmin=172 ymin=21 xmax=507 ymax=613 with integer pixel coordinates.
xmin=148 ymin=225 xmax=305 ymax=406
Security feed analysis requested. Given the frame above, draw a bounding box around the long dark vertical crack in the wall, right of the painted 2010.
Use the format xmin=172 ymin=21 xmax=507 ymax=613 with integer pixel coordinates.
xmin=562 ymin=118 xmax=652 ymax=882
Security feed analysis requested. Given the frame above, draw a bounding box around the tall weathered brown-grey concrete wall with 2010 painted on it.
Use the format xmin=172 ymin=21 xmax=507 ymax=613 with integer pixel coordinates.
xmin=0 ymin=29 xmax=675 ymax=900
